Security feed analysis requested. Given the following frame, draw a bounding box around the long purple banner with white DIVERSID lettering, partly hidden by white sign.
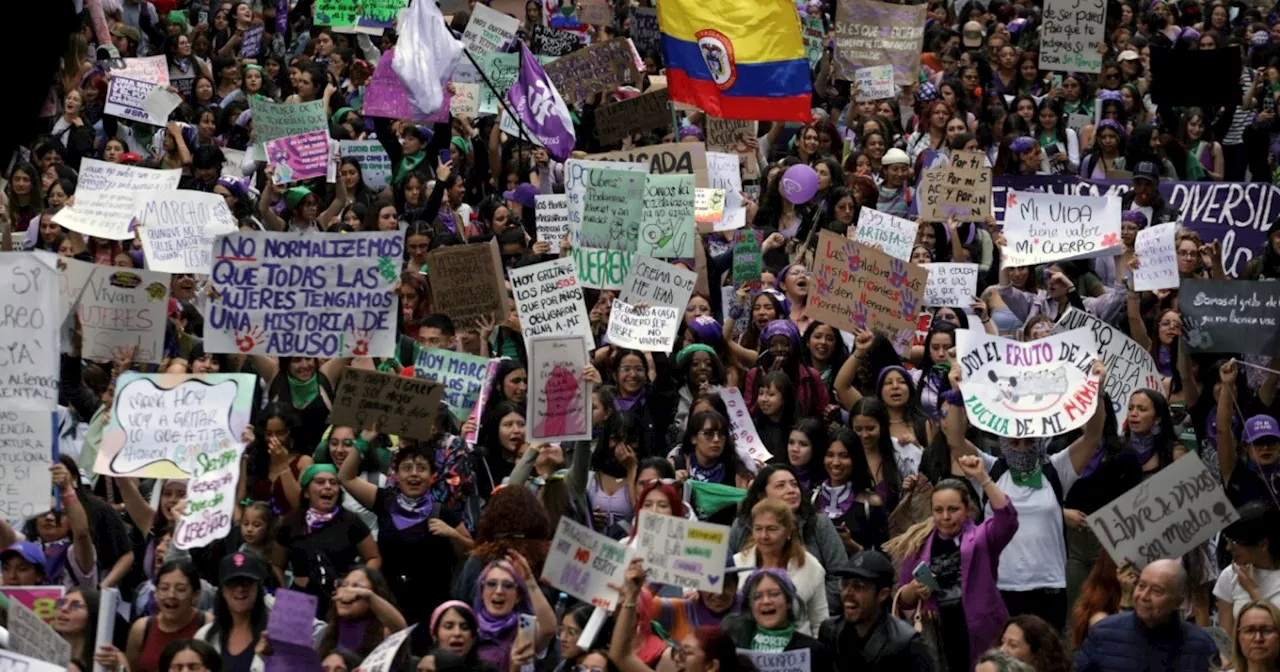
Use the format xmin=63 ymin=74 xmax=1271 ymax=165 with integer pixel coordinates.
xmin=991 ymin=175 xmax=1280 ymax=278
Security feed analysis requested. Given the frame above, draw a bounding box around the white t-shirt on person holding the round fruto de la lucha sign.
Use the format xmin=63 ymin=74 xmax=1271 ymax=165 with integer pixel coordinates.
xmin=987 ymin=451 xmax=1079 ymax=591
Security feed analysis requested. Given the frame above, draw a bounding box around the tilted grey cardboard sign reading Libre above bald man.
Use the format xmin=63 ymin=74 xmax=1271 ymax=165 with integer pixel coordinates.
xmin=1088 ymin=453 xmax=1240 ymax=568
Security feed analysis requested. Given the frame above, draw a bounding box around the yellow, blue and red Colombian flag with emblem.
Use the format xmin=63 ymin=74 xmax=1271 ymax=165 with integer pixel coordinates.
xmin=658 ymin=0 xmax=813 ymax=122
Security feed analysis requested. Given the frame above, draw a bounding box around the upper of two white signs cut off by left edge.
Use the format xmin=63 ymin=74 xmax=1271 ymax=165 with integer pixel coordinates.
xmin=0 ymin=252 xmax=63 ymax=409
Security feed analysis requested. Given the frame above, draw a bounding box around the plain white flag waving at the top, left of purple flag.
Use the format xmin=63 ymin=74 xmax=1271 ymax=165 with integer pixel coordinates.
xmin=392 ymin=1 xmax=462 ymax=116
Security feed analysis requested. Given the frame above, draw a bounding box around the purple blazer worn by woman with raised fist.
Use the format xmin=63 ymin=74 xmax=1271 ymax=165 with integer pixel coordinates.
xmin=897 ymin=494 xmax=1018 ymax=669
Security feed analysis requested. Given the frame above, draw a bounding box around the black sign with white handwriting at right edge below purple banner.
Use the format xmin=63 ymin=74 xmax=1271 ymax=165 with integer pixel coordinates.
xmin=1178 ymin=279 xmax=1280 ymax=357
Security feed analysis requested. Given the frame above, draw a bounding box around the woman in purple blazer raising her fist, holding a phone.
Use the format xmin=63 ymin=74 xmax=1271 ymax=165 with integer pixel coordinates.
xmin=886 ymin=450 xmax=1018 ymax=672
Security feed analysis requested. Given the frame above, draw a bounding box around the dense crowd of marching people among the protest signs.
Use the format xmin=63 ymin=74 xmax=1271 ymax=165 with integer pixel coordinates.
xmin=0 ymin=0 xmax=1280 ymax=672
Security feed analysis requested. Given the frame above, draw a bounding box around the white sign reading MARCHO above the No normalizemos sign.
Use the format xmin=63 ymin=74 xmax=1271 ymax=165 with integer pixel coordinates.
xmin=136 ymin=189 xmax=237 ymax=275
